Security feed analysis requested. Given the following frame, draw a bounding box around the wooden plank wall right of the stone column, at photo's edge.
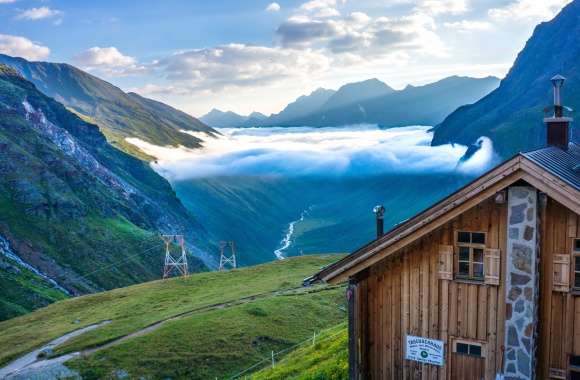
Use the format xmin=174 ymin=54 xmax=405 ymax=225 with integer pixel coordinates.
xmin=538 ymin=199 xmax=580 ymax=379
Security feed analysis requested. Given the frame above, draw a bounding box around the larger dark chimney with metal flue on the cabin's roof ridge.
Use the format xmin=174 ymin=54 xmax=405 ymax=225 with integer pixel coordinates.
xmin=544 ymin=75 xmax=572 ymax=150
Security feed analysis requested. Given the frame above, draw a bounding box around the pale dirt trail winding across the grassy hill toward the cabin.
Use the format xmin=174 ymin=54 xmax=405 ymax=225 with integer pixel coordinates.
xmin=0 ymin=285 xmax=341 ymax=380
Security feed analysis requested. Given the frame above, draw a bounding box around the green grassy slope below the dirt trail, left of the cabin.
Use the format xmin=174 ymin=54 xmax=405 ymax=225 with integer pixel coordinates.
xmin=67 ymin=288 xmax=346 ymax=379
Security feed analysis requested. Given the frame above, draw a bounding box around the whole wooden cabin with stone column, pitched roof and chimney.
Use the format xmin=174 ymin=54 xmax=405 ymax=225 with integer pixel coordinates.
xmin=311 ymin=78 xmax=580 ymax=380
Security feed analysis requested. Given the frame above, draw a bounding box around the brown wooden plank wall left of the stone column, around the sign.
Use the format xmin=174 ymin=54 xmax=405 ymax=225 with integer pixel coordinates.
xmin=357 ymin=200 xmax=507 ymax=379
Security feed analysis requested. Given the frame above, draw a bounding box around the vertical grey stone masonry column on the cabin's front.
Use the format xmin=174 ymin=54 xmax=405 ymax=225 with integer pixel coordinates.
xmin=504 ymin=187 xmax=538 ymax=380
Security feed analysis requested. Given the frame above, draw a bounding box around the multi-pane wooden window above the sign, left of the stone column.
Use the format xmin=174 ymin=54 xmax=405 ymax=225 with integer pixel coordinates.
xmin=456 ymin=231 xmax=486 ymax=281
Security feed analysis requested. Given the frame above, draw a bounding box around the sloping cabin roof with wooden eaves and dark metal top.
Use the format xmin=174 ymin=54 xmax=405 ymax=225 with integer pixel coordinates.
xmin=307 ymin=143 xmax=580 ymax=283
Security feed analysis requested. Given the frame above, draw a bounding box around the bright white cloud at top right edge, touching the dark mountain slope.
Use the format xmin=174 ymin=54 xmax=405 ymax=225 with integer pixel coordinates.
xmin=488 ymin=0 xmax=572 ymax=22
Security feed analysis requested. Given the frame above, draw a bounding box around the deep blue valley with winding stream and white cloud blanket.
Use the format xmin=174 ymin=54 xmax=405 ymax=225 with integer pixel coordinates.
xmin=132 ymin=125 xmax=495 ymax=265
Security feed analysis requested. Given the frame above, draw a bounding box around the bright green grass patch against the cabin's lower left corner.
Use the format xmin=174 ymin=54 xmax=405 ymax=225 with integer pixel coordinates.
xmin=249 ymin=323 xmax=348 ymax=380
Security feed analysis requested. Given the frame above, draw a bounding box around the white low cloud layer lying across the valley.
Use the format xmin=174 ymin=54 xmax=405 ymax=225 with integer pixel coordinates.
xmin=128 ymin=126 xmax=493 ymax=181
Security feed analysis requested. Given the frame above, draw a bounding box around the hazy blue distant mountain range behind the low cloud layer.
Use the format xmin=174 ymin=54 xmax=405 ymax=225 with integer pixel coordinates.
xmin=201 ymin=76 xmax=499 ymax=127
